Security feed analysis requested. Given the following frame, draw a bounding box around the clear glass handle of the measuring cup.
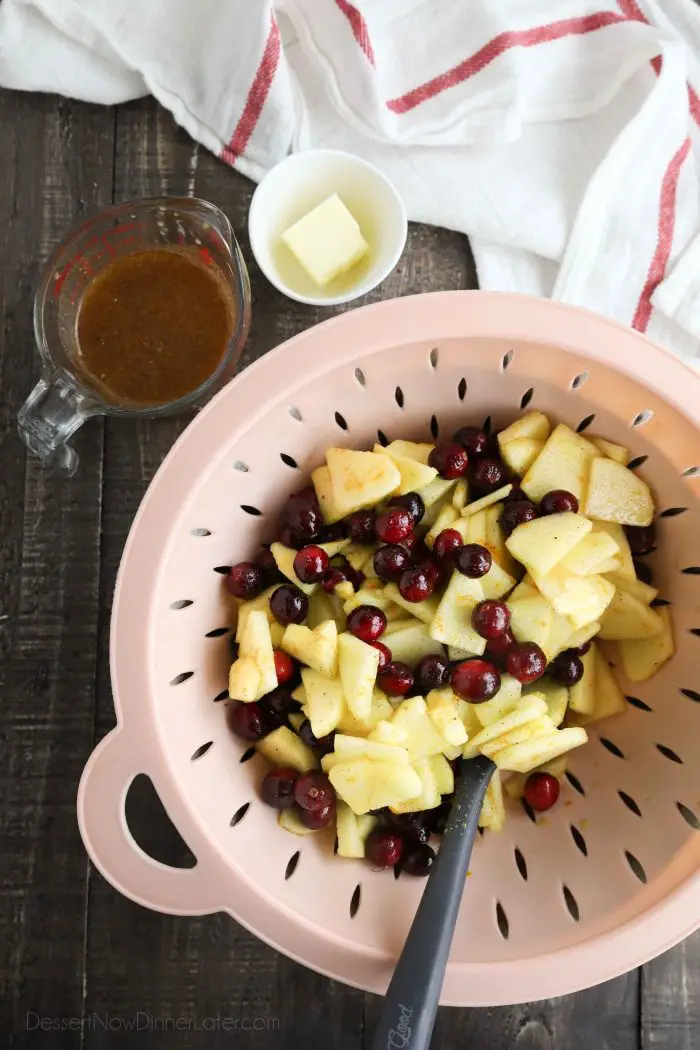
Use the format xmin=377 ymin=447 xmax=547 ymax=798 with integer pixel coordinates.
xmin=17 ymin=373 xmax=91 ymax=475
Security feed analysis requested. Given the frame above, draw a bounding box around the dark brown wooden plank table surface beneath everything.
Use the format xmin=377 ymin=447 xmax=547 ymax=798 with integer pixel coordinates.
xmin=0 ymin=92 xmax=700 ymax=1050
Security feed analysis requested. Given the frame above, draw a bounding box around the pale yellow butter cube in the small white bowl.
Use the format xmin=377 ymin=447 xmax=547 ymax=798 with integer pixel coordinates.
xmin=282 ymin=193 xmax=369 ymax=288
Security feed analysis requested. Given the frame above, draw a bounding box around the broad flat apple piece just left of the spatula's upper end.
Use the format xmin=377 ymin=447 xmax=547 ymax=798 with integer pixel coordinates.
xmin=328 ymin=758 xmax=423 ymax=816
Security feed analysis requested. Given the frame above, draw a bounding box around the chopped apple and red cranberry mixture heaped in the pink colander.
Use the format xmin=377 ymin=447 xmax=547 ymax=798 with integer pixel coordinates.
xmin=226 ymin=412 xmax=674 ymax=875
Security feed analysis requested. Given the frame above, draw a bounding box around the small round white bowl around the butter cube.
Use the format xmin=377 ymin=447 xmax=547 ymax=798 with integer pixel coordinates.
xmin=248 ymin=149 xmax=407 ymax=307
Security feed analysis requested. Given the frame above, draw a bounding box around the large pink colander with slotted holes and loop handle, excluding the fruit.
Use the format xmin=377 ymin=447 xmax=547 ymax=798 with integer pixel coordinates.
xmin=78 ymin=292 xmax=700 ymax=1006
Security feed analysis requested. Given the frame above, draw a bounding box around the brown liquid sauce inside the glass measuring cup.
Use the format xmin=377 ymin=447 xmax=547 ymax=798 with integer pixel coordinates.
xmin=77 ymin=248 xmax=235 ymax=406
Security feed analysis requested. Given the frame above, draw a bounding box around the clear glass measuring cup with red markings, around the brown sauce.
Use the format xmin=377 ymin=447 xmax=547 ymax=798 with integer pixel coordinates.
xmin=18 ymin=197 xmax=251 ymax=474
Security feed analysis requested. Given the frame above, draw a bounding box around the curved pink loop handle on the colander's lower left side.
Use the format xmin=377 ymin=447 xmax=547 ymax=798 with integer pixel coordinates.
xmin=78 ymin=728 xmax=221 ymax=915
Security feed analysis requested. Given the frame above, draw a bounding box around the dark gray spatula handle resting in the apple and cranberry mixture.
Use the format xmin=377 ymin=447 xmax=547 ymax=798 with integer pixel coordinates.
xmin=372 ymin=755 xmax=495 ymax=1050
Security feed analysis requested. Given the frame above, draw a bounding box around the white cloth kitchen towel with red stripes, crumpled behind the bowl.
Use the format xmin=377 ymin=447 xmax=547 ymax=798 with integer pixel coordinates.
xmin=0 ymin=0 xmax=700 ymax=357
